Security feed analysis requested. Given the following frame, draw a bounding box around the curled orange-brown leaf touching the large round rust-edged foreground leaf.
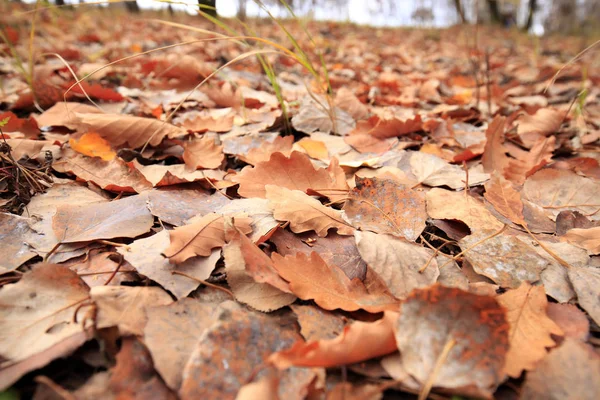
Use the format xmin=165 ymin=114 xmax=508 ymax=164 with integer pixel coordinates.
xmin=269 ymin=311 xmax=398 ymax=369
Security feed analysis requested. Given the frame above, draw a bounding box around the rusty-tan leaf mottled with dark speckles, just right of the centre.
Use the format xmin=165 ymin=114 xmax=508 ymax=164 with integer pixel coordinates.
xmin=343 ymin=177 xmax=427 ymax=241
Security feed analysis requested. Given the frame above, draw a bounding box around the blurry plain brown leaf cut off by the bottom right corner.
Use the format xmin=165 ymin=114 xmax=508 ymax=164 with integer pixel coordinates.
xmin=521 ymin=338 xmax=600 ymax=400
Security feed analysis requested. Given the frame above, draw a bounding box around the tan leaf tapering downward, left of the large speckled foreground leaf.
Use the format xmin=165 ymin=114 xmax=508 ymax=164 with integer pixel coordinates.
xmin=144 ymin=298 xmax=214 ymax=391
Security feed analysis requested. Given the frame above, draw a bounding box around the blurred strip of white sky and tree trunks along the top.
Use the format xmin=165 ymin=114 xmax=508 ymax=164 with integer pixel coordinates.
xmin=13 ymin=0 xmax=600 ymax=36
